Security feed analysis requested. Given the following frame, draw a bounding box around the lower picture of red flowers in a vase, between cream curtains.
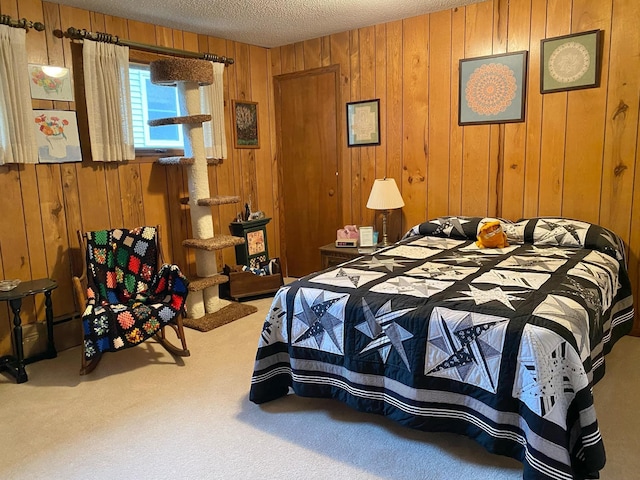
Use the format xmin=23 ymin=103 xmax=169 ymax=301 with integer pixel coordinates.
xmin=33 ymin=110 xmax=82 ymax=163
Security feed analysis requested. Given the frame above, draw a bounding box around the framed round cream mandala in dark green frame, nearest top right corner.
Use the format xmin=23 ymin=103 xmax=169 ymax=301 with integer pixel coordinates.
xmin=540 ymin=30 xmax=602 ymax=93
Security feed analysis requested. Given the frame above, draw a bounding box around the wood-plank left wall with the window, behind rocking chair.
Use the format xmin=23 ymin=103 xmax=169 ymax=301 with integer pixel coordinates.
xmin=0 ymin=0 xmax=279 ymax=355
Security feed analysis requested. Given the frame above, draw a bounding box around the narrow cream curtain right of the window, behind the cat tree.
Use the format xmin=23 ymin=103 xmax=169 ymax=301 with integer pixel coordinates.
xmin=200 ymin=62 xmax=227 ymax=159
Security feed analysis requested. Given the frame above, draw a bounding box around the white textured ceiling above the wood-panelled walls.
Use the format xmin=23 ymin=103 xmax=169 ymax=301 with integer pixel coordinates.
xmin=49 ymin=0 xmax=479 ymax=47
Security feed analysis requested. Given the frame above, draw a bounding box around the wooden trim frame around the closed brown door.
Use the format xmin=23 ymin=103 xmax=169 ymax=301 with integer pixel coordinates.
xmin=273 ymin=64 xmax=344 ymax=276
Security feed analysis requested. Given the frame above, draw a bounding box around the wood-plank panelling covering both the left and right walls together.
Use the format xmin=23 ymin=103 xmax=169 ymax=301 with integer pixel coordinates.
xmin=0 ymin=0 xmax=640 ymax=353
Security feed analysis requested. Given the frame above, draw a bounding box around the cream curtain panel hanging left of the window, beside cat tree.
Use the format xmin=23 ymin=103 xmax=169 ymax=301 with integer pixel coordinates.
xmin=82 ymin=40 xmax=135 ymax=162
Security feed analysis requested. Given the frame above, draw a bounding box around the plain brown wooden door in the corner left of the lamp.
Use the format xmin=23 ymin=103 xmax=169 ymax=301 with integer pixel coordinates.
xmin=274 ymin=66 xmax=342 ymax=277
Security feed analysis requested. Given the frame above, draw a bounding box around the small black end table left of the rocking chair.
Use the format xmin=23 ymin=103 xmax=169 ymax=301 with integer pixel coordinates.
xmin=0 ymin=278 xmax=58 ymax=383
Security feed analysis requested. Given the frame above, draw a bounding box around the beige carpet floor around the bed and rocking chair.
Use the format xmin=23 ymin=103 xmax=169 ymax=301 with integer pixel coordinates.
xmin=0 ymin=292 xmax=640 ymax=480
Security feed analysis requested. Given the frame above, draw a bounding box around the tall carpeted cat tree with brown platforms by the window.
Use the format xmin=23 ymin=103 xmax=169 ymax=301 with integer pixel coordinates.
xmin=149 ymin=58 xmax=257 ymax=331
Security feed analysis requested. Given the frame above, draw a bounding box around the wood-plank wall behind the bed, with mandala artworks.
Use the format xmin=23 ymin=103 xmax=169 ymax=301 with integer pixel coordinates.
xmin=271 ymin=0 xmax=640 ymax=333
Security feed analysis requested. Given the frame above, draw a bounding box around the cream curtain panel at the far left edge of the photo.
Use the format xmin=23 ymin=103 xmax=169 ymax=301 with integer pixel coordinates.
xmin=0 ymin=25 xmax=38 ymax=165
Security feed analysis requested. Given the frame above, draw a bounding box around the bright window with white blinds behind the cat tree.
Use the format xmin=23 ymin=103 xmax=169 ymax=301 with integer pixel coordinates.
xmin=129 ymin=63 xmax=184 ymax=153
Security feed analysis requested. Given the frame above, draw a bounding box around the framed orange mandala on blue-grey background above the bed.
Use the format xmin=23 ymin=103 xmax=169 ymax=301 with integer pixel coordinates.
xmin=458 ymin=51 xmax=527 ymax=125
